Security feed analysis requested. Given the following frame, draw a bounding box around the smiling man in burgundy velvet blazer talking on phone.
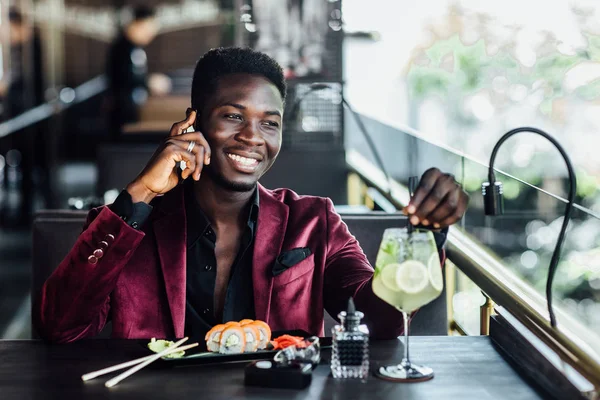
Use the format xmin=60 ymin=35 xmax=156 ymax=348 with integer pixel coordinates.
xmin=34 ymin=48 xmax=467 ymax=342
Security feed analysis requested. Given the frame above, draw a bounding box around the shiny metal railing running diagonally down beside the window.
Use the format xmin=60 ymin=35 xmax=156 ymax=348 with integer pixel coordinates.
xmin=346 ymin=150 xmax=600 ymax=388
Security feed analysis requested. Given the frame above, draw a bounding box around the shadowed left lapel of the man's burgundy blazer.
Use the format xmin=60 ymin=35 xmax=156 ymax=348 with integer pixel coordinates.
xmin=153 ymin=185 xmax=186 ymax=338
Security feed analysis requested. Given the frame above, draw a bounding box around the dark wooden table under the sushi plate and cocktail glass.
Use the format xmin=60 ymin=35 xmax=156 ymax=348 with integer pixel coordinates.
xmin=0 ymin=337 xmax=543 ymax=400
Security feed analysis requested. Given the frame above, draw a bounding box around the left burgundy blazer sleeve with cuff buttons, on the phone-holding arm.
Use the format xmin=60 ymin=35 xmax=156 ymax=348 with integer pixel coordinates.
xmin=33 ymin=207 xmax=145 ymax=343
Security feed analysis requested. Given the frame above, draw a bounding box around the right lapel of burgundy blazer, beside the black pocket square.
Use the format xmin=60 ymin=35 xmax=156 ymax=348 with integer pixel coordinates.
xmin=252 ymin=184 xmax=289 ymax=323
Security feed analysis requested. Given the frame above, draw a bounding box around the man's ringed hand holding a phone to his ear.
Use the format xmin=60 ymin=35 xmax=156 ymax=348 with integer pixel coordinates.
xmin=127 ymin=108 xmax=211 ymax=203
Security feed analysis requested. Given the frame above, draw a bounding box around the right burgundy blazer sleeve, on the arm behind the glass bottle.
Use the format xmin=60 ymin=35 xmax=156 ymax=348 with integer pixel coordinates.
xmin=323 ymin=199 xmax=403 ymax=339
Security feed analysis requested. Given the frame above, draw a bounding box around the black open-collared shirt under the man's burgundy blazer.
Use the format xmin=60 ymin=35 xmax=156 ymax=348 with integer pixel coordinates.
xmin=184 ymin=182 xmax=259 ymax=339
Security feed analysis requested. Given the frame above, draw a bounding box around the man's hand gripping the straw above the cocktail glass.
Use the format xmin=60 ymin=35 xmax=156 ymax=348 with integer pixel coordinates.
xmin=403 ymin=168 xmax=469 ymax=229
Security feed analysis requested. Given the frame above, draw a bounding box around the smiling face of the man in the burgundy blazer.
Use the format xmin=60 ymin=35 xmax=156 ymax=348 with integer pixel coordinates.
xmin=199 ymin=74 xmax=283 ymax=192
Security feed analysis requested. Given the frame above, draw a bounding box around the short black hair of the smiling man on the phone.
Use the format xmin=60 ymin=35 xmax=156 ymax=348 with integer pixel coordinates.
xmin=192 ymin=47 xmax=286 ymax=113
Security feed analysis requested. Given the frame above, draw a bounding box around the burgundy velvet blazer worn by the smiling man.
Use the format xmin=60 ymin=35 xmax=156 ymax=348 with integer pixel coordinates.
xmin=33 ymin=185 xmax=402 ymax=342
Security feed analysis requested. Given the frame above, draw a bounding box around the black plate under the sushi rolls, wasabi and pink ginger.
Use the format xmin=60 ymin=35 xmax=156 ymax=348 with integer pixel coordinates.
xmin=143 ymin=330 xmax=331 ymax=367
